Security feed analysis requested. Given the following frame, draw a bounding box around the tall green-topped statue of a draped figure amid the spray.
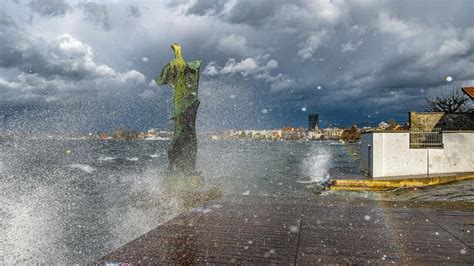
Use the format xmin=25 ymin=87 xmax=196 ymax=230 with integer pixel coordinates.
xmin=155 ymin=43 xmax=201 ymax=175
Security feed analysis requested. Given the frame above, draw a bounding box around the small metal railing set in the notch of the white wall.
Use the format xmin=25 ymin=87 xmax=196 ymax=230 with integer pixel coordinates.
xmin=410 ymin=128 xmax=443 ymax=149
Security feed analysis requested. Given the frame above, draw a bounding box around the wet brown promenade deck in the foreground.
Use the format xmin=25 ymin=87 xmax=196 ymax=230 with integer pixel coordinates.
xmin=97 ymin=195 xmax=474 ymax=265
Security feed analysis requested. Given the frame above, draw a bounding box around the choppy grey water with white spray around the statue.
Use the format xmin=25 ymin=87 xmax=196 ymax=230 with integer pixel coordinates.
xmin=0 ymin=140 xmax=474 ymax=264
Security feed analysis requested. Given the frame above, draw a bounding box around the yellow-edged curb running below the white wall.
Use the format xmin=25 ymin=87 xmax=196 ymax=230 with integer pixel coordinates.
xmin=330 ymin=174 xmax=474 ymax=191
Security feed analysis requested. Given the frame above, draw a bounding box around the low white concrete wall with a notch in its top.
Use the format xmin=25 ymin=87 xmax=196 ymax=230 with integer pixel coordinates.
xmin=361 ymin=132 xmax=474 ymax=178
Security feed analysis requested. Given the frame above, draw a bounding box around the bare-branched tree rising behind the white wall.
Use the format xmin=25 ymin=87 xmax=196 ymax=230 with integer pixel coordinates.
xmin=425 ymin=88 xmax=469 ymax=114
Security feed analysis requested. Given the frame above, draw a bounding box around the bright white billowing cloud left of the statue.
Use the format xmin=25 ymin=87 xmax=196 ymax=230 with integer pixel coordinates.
xmin=0 ymin=34 xmax=146 ymax=103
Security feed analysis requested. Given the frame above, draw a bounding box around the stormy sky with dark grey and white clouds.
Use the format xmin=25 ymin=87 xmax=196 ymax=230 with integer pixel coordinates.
xmin=0 ymin=0 xmax=474 ymax=132
